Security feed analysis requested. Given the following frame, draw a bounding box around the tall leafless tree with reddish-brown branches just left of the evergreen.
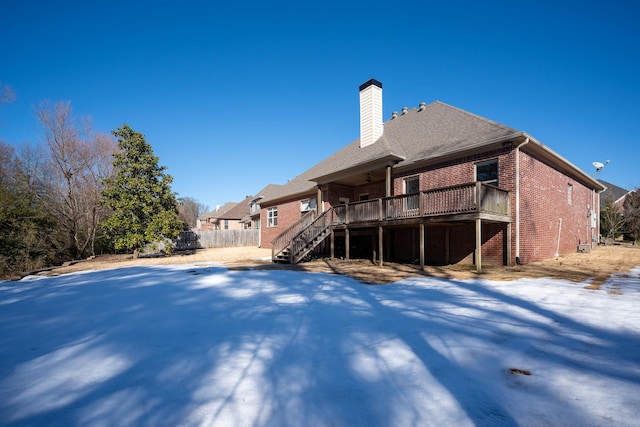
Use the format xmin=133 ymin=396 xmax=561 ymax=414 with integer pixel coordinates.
xmin=35 ymin=102 xmax=117 ymax=259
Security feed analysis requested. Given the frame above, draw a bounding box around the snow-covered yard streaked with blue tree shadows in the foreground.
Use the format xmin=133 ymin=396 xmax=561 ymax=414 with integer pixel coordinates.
xmin=0 ymin=265 xmax=640 ymax=427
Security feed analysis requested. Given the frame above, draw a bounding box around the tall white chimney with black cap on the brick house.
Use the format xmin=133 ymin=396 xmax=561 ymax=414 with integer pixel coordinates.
xmin=360 ymin=79 xmax=384 ymax=148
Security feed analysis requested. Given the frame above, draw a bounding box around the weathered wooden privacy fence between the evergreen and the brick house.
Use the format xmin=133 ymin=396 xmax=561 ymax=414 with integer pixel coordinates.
xmin=175 ymin=230 xmax=260 ymax=251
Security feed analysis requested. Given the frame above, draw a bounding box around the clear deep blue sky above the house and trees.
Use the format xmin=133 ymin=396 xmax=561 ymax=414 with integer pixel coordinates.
xmin=0 ymin=0 xmax=640 ymax=208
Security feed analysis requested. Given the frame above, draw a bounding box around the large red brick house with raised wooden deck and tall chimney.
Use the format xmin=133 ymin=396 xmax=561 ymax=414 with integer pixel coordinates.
xmin=260 ymin=79 xmax=604 ymax=270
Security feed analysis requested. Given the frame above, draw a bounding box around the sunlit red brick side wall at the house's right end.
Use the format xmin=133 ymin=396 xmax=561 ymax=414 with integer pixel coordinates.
xmin=513 ymin=151 xmax=592 ymax=263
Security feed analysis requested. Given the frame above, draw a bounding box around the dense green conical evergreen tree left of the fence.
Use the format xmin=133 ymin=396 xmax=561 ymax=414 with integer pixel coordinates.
xmin=102 ymin=124 xmax=183 ymax=256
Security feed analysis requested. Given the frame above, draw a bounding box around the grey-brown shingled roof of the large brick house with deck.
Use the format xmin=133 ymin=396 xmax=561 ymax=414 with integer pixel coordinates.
xmin=265 ymin=101 xmax=523 ymax=206
